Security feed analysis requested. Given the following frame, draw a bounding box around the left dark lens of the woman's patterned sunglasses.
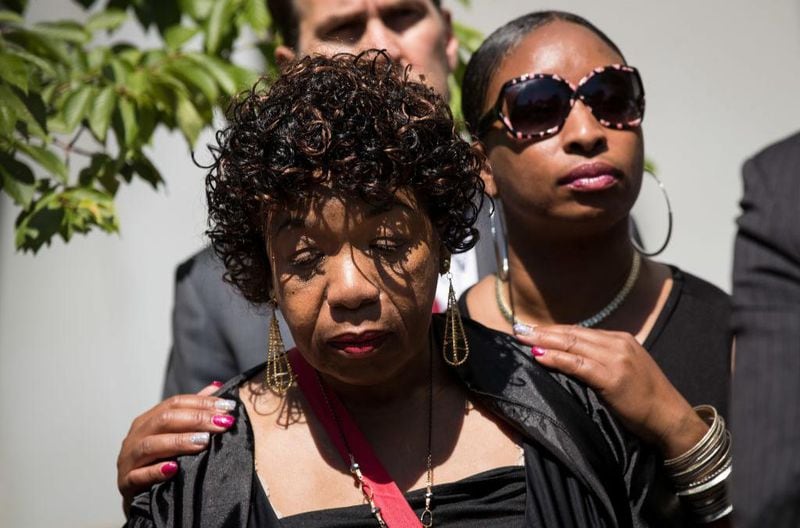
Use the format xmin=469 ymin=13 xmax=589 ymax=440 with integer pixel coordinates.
xmin=502 ymin=78 xmax=570 ymax=136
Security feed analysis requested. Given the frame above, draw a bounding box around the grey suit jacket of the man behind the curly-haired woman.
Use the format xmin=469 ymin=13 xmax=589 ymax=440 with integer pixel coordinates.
xmin=164 ymin=247 xmax=294 ymax=398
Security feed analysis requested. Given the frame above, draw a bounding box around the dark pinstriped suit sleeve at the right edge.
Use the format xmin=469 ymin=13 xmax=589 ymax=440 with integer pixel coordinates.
xmin=732 ymin=130 xmax=800 ymax=528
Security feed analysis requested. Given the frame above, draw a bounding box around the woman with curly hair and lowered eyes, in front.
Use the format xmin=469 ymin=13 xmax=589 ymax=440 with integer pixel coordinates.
xmin=128 ymin=52 xmax=692 ymax=528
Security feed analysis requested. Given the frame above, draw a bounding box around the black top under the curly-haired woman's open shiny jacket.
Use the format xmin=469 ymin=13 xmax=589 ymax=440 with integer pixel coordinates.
xmin=247 ymin=466 xmax=525 ymax=528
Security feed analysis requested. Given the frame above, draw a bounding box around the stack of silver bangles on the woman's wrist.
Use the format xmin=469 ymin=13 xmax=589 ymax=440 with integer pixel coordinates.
xmin=664 ymin=405 xmax=733 ymax=523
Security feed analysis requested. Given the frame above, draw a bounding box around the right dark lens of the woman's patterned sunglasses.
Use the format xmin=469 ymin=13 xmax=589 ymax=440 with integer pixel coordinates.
xmin=579 ymin=68 xmax=644 ymax=127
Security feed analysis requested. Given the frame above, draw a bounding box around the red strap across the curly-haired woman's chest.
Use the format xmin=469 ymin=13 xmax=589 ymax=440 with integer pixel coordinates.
xmin=288 ymin=348 xmax=422 ymax=528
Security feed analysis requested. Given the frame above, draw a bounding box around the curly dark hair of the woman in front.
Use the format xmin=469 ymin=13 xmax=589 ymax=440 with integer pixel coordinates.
xmin=206 ymin=50 xmax=486 ymax=303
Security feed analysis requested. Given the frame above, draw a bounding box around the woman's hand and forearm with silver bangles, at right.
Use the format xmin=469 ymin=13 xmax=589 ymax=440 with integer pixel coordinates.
xmin=520 ymin=325 xmax=730 ymax=526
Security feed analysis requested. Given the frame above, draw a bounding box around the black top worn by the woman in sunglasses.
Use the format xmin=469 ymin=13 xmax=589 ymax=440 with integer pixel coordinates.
xmin=458 ymin=266 xmax=733 ymax=416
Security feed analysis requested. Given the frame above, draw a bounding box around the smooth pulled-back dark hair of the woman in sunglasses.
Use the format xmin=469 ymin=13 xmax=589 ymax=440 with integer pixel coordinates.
xmin=461 ymin=10 xmax=625 ymax=133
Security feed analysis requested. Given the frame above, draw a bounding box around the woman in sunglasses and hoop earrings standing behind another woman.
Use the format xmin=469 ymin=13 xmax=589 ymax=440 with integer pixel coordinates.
xmin=460 ymin=11 xmax=731 ymax=522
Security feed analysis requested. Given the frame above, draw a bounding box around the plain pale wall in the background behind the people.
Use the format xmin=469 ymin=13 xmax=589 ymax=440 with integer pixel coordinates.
xmin=0 ymin=0 xmax=800 ymax=527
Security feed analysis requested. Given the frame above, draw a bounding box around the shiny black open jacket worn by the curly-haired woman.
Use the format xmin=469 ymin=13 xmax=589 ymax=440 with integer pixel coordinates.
xmin=126 ymin=315 xmax=686 ymax=528
